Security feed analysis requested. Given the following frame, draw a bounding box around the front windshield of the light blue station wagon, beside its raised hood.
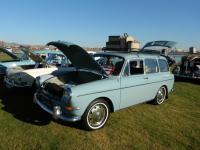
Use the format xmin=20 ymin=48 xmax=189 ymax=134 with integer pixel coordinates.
xmin=93 ymin=54 xmax=124 ymax=76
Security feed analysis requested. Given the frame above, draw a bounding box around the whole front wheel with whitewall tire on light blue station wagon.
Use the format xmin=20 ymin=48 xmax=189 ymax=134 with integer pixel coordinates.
xmin=82 ymin=99 xmax=110 ymax=130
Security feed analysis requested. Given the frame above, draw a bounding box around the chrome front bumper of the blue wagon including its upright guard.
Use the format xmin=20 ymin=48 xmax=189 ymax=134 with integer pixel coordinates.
xmin=33 ymin=94 xmax=81 ymax=122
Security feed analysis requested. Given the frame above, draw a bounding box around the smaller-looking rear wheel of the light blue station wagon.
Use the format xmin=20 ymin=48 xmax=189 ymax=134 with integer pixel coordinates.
xmin=153 ymin=86 xmax=167 ymax=105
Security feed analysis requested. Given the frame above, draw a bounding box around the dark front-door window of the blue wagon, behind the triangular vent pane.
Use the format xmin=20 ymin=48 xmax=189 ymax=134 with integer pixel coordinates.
xmin=129 ymin=60 xmax=144 ymax=75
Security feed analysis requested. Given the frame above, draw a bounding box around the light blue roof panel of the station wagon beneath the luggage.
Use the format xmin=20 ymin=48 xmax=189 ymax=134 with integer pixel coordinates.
xmin=96 ymin=51 xmax=165 ymax=59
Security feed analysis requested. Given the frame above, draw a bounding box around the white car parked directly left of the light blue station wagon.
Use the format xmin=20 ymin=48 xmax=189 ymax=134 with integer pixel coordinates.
xmin=4 ymin=50 xmax=68 ymax=88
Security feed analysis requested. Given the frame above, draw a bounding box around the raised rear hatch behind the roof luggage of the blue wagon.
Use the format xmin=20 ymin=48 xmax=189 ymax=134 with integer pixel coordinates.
xmin=142 ymin=41 xmax=176 ymax=50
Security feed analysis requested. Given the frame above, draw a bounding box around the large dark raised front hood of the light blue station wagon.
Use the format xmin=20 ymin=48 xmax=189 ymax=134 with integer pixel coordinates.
xmin=47 ymin=41 xmax=108 ymax=76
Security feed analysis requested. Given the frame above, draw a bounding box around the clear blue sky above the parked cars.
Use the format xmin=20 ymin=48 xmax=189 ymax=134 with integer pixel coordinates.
xmin=0 ymin=0 xmax=200 ymax=49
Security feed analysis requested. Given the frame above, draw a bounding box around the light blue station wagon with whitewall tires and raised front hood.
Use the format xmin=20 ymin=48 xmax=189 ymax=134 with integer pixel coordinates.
xmin=34 ymin=41 xmax=174 ymax=130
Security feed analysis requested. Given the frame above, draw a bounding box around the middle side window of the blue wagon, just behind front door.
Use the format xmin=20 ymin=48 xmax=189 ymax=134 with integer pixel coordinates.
xmin=145 ymin=59 xmax=158 ymax=74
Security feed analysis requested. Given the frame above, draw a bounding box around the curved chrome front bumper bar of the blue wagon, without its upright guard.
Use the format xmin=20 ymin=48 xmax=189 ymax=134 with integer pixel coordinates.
xmin=33 ymin=93 xmax=81 ymax=122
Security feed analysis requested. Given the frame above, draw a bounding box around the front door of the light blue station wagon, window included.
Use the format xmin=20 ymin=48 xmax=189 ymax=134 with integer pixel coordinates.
xmin=120 ymin=59 xmax=149 ymax=108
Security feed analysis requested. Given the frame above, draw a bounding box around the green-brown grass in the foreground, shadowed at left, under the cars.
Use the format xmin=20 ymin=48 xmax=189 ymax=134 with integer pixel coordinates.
xmin=0 ymin=82 xmax=200 ymax=150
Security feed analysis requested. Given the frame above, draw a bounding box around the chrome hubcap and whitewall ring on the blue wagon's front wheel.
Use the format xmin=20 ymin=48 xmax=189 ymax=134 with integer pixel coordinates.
xmin=87 ymin=103 xmax=108 ymax=128
